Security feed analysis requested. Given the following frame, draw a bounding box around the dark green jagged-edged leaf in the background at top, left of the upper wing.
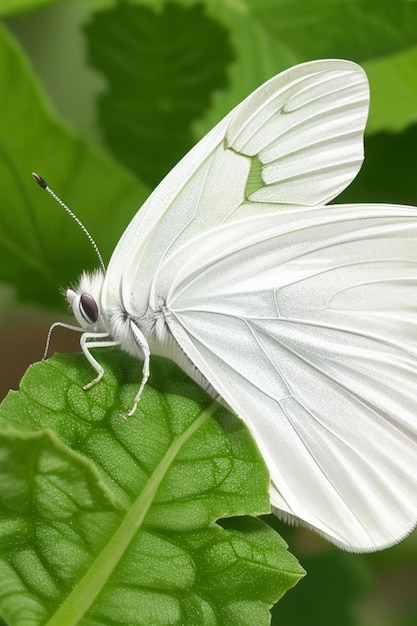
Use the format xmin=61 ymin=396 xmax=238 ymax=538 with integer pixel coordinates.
xmin=86 ymin=3 xmax=233 ymax=186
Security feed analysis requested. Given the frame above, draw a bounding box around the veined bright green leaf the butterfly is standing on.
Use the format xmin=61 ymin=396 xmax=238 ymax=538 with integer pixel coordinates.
xmin=0 ymin=351 xmax=303 ymax=626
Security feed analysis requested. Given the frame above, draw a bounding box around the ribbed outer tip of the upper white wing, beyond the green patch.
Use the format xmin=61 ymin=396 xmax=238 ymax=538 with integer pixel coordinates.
xmin=226 ymin=61 xmax=369 ymax=206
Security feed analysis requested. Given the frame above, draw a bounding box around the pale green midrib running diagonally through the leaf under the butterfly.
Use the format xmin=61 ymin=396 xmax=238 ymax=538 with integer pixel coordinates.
xmin=46 ymin=401 xmax=219 ymax=626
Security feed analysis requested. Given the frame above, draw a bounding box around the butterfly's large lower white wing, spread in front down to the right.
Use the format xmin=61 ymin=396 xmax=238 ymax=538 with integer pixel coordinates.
xmin=155 ymin=205 xmax=417 ymax=550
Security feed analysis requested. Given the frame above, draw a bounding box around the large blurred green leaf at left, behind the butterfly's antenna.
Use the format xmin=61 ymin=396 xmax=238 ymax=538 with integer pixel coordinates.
xmin=0 ymin=20 xmax=147 ymax=305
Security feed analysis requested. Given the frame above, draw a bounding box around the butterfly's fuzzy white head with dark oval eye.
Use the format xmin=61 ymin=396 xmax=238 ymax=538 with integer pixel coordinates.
xmin=65 ymin=271 xmax=105 ymax=332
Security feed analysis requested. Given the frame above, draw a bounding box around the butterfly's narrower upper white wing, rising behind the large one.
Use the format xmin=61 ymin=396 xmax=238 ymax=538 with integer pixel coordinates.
xmin=102 ymin=60 xmax=369 ymax=315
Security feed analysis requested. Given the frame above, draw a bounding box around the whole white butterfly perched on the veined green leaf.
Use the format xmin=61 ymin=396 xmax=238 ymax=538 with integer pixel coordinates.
xmin=49 ymin=60 xmax=417 ymax=550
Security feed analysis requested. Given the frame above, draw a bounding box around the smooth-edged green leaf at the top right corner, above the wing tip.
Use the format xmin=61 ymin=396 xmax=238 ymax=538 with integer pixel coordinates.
xmin=246 ymin=0 xmax=417 ymax=60
